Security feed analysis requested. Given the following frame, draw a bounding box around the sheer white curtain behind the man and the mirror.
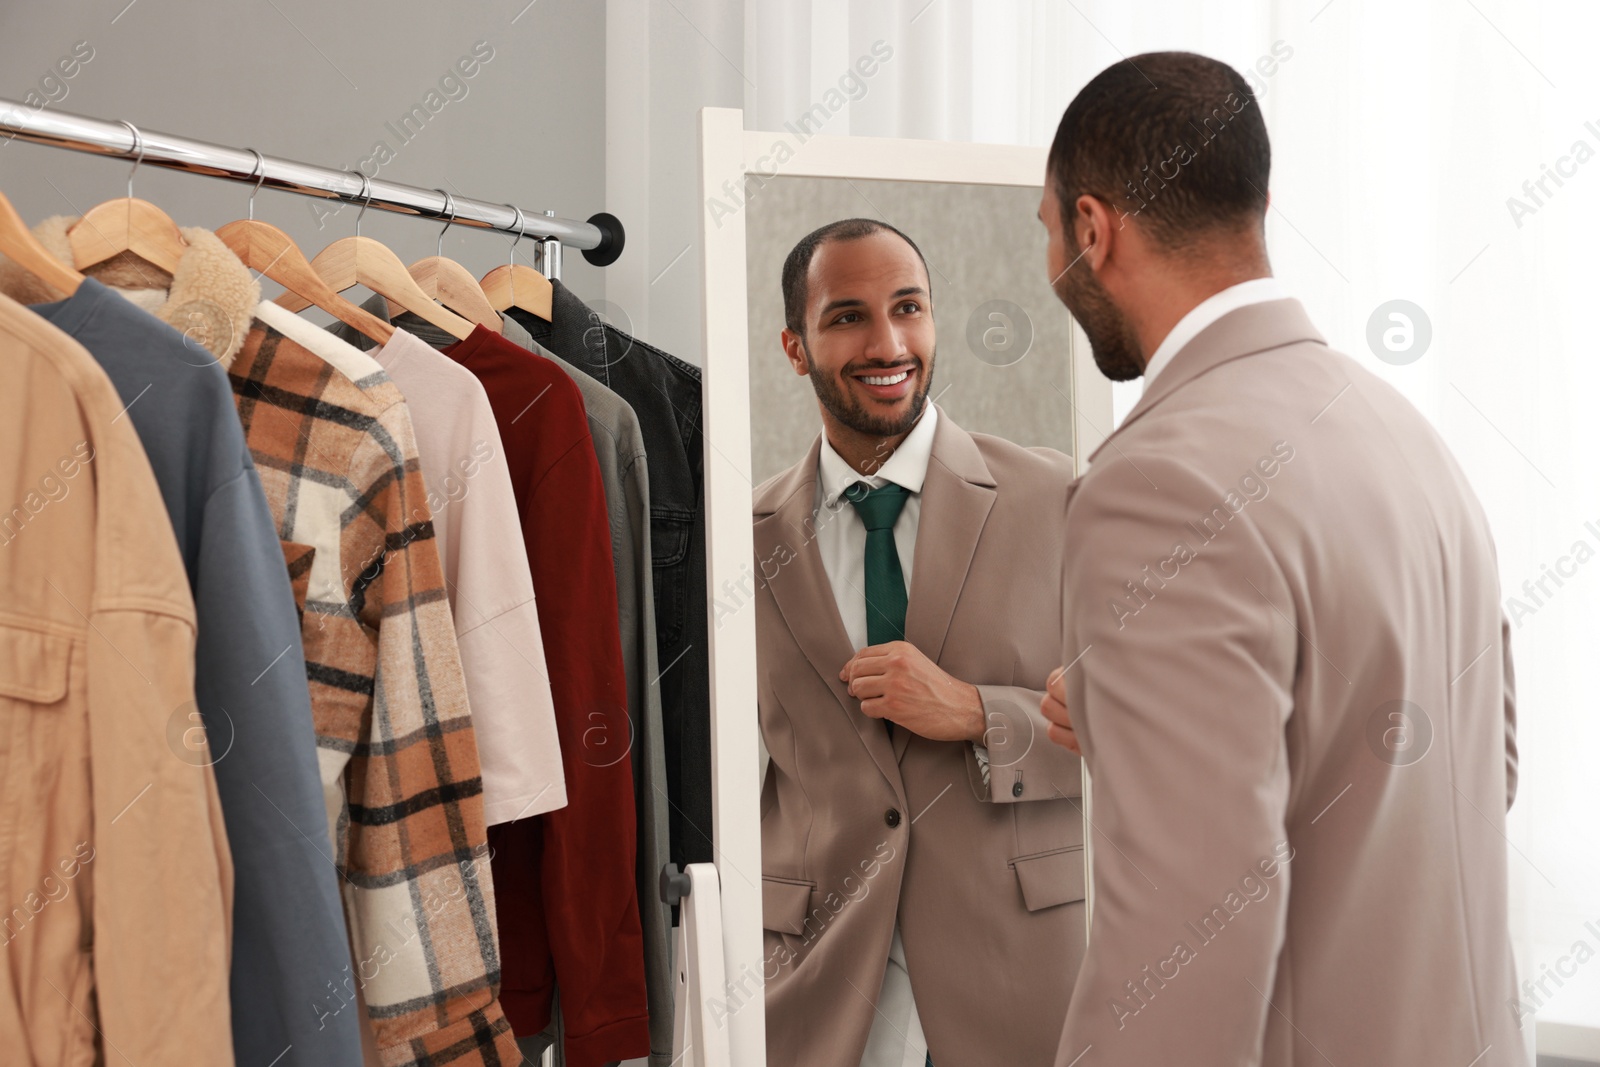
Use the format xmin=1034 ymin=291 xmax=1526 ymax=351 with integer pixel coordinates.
xmin=744 ymin=0 xmax=1600 ymax=1061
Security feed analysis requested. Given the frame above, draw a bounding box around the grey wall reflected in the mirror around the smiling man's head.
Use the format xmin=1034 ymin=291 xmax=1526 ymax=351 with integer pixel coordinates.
xmin=746 ymin=178 xmax=1072 ymax=485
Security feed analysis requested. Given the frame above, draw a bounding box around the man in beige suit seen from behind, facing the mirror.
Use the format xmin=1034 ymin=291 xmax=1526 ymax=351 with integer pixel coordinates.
xmin=1040 ymin=53 xmax=1526 ymax=1067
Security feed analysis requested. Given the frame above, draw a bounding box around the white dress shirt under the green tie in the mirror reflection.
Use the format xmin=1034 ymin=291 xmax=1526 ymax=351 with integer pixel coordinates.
xmin=816 ymin=403 xmax=939 ymax=1067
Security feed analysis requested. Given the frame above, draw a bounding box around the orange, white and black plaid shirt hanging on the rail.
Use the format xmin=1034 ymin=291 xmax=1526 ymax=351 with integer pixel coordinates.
xmin=229 ymin=318 xmax=508 ymax=1067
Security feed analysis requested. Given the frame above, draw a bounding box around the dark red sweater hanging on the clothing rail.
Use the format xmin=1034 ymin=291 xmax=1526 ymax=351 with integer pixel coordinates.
xmin=445 ymin=326 xmax=650 ymax=1067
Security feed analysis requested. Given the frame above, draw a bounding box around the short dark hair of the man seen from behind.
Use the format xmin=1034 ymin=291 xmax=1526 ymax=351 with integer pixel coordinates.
xmin=1046 ymin=51 xmax=1272 ymax=251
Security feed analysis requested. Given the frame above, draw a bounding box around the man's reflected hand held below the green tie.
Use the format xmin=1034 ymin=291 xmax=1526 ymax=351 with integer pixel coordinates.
xmin=838 ymin=641 xmax=984 ymax=744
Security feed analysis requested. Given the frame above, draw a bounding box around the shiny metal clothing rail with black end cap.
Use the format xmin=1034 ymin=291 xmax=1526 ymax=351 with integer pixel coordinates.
xmin=0 ymin=98 xmax=624 ymax=267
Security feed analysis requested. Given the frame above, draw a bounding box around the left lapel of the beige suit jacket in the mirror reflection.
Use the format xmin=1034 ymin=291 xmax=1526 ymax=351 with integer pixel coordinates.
xmin=755 ymin=437 xmax=906 ymax=808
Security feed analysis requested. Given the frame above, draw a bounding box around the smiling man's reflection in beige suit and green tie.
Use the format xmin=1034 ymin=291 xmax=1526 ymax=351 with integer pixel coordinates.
xmin=755 ymin=219 xmax=1085 ymax=1067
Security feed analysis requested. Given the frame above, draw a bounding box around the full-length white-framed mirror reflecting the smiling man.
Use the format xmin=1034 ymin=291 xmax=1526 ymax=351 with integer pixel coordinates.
xmin=707 ymin=110 xmax=1109 ymax=1067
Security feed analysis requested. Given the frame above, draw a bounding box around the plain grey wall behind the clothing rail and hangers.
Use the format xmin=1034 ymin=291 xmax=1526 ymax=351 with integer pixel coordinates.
xmin=0 ymin=0 xmax=604 ymax=298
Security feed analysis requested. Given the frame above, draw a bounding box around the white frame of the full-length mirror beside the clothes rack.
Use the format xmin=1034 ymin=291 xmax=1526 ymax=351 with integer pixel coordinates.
xmin=690 ymin=107 xmax=1112 ymax=1067
